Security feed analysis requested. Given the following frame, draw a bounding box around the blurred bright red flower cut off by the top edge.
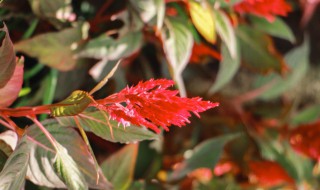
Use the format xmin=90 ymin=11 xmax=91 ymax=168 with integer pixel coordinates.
xmin=234 ymin=0 xmax=291 ymax=22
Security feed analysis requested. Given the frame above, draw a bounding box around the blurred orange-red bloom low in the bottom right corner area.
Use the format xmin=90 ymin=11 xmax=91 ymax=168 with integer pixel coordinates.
xmin=249 ymin=161 xmax=294 ymax=187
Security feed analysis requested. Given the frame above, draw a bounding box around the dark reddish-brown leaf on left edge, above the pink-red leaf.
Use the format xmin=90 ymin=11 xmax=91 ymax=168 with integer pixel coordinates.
xmin=0 ymin=23 xmax=16 ymax=88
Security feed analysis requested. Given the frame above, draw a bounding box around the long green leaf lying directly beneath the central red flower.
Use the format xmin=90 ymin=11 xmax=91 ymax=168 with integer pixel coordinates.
xmin=57 ymin=111 xmax=158 ymax=143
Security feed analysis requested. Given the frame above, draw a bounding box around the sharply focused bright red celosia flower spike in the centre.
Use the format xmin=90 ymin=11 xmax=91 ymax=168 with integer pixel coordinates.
xmin=99 ymin=79 xmax=218 ymax=133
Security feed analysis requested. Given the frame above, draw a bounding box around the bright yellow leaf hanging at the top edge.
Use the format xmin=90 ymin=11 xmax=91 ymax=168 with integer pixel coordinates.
xmin=189 ymin=1 xmax=216 ymax=43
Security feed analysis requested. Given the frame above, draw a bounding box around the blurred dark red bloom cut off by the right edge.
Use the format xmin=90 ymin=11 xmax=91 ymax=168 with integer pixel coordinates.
xmin=290 ymin=121 xmax=320 ymax=160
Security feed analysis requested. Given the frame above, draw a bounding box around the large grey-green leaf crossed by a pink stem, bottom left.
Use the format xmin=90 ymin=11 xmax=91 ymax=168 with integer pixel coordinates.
xmin=26 ymin=119 xmax=111 ymax=189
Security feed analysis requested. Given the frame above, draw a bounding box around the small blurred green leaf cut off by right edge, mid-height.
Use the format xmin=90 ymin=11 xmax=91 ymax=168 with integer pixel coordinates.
xmin=291 ymin=105 xmax=320 ymax=125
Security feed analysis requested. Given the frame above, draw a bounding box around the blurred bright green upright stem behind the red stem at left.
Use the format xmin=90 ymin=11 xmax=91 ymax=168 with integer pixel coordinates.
xmin=39 ymin=69 xmax=59 ymax=121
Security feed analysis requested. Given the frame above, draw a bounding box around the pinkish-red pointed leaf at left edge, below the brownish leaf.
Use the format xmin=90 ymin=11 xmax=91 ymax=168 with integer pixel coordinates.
xmin=0 ymin=58 xmax=24 ymax=107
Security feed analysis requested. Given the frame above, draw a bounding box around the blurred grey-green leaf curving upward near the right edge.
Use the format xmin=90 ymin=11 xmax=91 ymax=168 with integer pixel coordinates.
xmin=256 ymin=41 xmax=309 ymax=100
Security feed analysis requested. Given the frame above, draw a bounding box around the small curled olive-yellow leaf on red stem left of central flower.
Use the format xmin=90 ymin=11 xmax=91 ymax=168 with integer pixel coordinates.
xmin=50 ymin=90 xmax=93 ymax=117
